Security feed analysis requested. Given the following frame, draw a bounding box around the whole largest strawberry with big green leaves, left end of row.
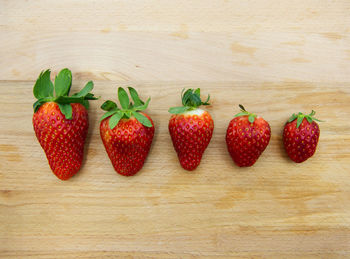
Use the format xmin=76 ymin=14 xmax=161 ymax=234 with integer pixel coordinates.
xmin=33 ymin=69 xmax=97 ymax=180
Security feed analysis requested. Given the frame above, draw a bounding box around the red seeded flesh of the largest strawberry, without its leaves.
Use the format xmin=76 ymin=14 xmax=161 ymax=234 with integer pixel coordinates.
xmin=33 ymin=102 xmax=89 ymax=180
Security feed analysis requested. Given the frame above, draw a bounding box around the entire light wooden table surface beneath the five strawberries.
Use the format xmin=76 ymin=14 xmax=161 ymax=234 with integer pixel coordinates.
xmin=0 ymin=0 xmax=350 ymax=258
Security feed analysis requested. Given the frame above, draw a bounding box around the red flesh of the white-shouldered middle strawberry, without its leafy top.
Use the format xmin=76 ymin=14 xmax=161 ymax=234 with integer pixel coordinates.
xmin=169 ymin=111 xmax=214 ymax=171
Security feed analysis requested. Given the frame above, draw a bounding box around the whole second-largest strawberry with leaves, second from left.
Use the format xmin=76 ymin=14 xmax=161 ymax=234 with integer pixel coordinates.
xmin=100 ymin=87 xmax=154 ymax=176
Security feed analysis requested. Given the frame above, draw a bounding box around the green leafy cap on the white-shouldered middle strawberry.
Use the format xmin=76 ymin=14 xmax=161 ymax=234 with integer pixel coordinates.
xmin=169 ymin=88 xmax=210 ymax=114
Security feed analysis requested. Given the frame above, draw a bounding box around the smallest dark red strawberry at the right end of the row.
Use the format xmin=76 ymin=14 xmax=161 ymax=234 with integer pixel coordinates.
xmin=283 ymin=111 xmax=320 ymax=163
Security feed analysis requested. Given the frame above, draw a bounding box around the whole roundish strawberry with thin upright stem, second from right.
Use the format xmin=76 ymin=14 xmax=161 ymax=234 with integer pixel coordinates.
xmin=226 ymin=105 xmax=271 ymax=167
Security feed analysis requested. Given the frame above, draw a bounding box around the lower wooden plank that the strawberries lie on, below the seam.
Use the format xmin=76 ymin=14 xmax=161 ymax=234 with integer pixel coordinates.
xmin=0 ymin=81 xmax=350 ymax=258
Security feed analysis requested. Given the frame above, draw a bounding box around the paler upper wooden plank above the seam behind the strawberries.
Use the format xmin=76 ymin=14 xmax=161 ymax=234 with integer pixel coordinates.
xmin=0 ymin=0 xmax=350 ymax=82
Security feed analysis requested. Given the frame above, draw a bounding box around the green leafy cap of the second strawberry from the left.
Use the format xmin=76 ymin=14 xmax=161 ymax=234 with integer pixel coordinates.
xmin=100 ymin=87 xmax=152 ymax=129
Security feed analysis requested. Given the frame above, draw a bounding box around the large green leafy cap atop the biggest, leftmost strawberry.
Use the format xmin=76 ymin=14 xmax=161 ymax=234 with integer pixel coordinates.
xmin=33 ymin=68 xmax=98 ymax=120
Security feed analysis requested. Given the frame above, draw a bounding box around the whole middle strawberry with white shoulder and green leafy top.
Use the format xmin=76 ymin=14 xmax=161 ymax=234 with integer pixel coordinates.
xmin=169 ymin=88 xmax=214 ymax=171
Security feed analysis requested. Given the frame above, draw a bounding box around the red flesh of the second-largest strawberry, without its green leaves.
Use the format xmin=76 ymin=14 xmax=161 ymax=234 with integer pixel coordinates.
xmin=100 ymin=113 xmax=154 ymax=176
